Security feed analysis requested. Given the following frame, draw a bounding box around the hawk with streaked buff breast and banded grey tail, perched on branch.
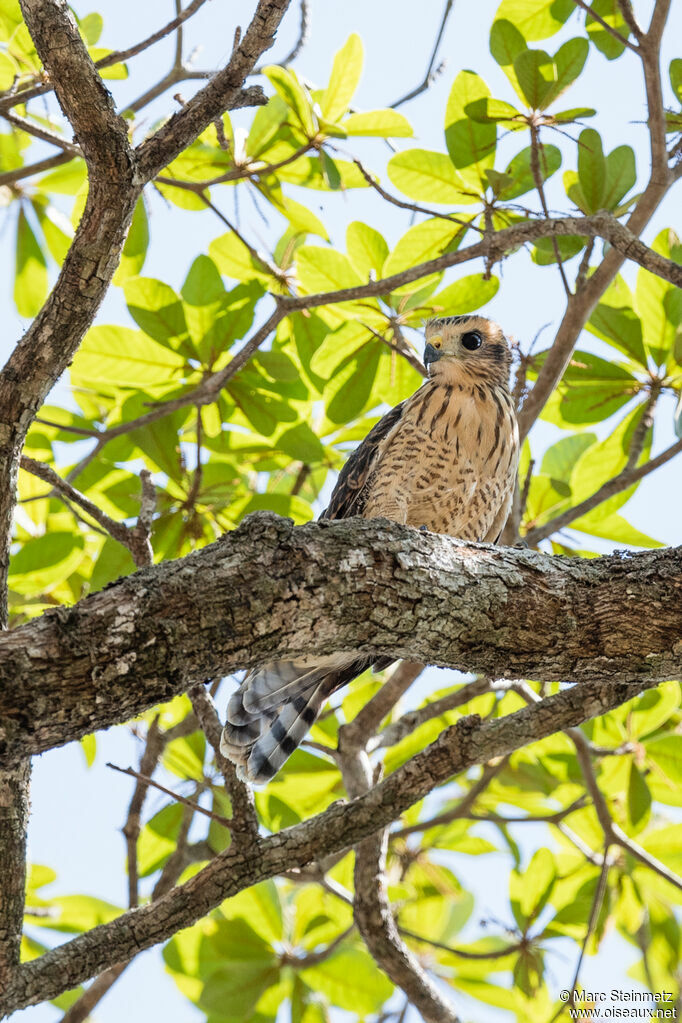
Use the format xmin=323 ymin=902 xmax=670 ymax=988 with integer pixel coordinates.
xmin=221 ymin=316 xmax=518 ymax=784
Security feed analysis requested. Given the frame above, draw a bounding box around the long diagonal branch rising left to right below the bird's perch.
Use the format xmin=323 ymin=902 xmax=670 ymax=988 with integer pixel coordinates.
xmin=0 ymin=676 xmax=662 ymax=1014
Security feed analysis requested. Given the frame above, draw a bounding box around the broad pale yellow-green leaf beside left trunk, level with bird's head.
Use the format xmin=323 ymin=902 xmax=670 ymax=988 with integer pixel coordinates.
xmin=71 ymin=326 xmax=184 ymax=394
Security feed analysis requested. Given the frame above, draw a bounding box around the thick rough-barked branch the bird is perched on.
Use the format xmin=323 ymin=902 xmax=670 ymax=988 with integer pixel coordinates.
xmin=0 ymin=513 xmax=682 ymax=762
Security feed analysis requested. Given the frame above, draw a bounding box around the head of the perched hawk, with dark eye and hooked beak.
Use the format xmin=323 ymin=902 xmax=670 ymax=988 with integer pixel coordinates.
xmin=424 ymin=316 xmax=511 ymax=385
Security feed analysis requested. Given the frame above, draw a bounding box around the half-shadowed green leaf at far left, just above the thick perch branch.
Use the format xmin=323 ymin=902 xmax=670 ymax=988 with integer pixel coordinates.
xmin=9 ymin=531 xmax=85 ymax=596
